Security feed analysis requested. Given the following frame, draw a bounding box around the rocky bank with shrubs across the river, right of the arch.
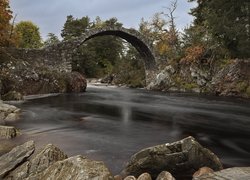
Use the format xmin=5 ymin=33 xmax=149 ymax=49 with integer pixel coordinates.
xmin=147 ymin=59 xmax=250 ymax=98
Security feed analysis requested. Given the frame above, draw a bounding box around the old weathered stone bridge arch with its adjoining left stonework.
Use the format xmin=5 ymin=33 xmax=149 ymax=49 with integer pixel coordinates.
xmin=42 ymin=27 xmax=158 ymax=85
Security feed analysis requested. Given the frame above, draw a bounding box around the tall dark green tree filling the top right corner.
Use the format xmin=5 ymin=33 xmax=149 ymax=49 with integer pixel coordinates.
xmin=189 ymin=0 xmax=250 ymax=58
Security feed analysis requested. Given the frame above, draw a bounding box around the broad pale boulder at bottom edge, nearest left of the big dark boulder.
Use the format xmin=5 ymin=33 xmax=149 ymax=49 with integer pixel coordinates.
xmin=28 ymin=156 xmax=114 ymax=180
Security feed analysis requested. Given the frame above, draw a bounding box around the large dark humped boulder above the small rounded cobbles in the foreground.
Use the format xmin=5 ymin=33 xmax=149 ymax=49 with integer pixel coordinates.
xmin=122 ymin=137 xmax=222 ymax=179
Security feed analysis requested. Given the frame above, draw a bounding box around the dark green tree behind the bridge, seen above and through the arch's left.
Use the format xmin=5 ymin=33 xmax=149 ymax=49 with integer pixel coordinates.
xmin=61 ymin=16 xmax=123 ymax=77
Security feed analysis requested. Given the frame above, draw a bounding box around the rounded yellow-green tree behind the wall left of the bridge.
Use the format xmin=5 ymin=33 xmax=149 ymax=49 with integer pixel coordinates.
xmin=15 ymin=21 xmax=42 ymax=48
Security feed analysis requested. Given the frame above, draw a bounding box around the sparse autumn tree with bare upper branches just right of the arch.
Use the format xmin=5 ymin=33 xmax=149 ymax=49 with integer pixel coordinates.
xmin=139 ymin=1 xmax=181 ymax=61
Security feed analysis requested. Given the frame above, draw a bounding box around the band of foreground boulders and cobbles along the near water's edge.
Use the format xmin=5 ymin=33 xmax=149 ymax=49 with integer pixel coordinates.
xmin=0 ymin=134 xmax=250 ymax=180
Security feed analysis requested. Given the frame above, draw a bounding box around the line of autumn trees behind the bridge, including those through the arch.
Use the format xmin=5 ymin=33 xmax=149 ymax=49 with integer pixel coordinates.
xmin=0 ymin=0 xmax=250 ymax=86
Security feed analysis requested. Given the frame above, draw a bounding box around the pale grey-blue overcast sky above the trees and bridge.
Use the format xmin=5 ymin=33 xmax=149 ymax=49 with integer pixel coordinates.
xmin=10 ymin=0 xmax=197 ymax=38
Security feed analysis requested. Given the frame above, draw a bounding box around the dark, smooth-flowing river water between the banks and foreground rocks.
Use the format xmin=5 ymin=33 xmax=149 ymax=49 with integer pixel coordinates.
xmin=3 ymin=86 xmax=250 ymax=174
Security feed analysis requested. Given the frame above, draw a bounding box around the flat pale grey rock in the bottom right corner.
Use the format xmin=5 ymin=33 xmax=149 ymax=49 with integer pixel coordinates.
xmin=193 ymin=167 xmax=250 ymax=180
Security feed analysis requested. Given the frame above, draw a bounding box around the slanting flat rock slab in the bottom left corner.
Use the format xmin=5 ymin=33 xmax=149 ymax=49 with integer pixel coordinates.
xmin=0 ymin=141 xmax=35 ymax=179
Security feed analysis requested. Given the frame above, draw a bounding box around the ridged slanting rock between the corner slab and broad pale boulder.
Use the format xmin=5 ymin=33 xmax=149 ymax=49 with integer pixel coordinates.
xmin=7 ymin=144 xmax=67 ymax=180
